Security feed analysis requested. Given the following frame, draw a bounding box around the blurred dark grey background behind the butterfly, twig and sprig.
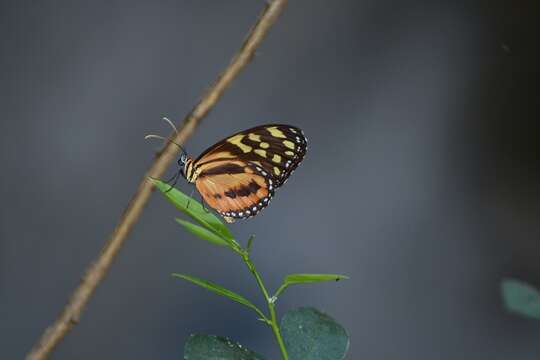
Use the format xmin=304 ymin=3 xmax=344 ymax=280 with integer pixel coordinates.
xmin=0 ymin=0 xmax=540 ymax=360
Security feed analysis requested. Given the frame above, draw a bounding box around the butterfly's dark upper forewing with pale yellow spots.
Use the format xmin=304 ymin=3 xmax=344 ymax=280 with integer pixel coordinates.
xmin=194 ymin=124 xmax=307 ymax=188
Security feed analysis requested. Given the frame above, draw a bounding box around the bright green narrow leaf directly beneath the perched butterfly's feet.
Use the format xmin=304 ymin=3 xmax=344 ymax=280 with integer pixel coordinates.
xmin=149 ymin=178 xmax=234 ymax=242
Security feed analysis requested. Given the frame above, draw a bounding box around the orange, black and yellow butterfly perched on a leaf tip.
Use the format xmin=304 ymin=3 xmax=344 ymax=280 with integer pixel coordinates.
xmin=166 ymin=124 xmax=307 ymax=223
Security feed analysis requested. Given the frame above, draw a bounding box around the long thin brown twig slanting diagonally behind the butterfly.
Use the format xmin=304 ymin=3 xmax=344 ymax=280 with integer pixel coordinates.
xmin=26 ymin=0 xmax=287 ymax=360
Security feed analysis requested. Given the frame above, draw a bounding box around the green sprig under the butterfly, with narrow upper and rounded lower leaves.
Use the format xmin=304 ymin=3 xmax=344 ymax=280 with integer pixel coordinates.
xmin=151 ymin=179 xmax=349 ymax=360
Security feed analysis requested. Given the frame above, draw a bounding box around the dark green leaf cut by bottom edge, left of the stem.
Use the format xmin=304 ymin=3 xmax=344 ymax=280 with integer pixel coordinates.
xmin=184 ymin=334 xmax=264 ymax=360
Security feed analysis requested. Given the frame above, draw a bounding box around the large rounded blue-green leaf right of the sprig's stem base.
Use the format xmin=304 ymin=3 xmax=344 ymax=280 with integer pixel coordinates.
xmin=280 ymin=307 xmax=349 ymax=360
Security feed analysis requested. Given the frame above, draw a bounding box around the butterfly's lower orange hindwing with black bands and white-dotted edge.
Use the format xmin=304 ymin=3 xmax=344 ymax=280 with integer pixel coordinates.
xmin=195 ymin=160 xmax=274 ymax=222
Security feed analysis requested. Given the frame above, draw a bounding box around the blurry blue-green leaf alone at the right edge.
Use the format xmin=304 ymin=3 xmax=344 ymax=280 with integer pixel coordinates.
xmin=501 ymin=279 xmax=540 ymax=319
